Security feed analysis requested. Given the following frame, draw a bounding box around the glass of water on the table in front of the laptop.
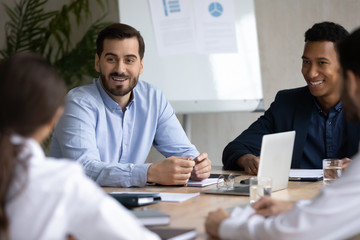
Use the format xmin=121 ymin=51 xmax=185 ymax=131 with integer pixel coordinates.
xmin=249 ymin=177 xmax=272 ymax=204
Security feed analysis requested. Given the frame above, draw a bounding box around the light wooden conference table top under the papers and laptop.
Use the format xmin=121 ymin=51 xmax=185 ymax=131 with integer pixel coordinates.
xmin=103 ymin=166 xmax=323 ymax=239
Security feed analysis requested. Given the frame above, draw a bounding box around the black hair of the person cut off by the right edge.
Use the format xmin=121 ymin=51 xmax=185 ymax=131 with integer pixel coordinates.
xmin=337 ymin=28 xmax=360 ymax=76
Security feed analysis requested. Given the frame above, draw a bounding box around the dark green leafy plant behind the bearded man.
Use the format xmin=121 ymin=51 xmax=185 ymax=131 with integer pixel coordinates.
xmin=0 ymin=0 xmax=109 ymax=89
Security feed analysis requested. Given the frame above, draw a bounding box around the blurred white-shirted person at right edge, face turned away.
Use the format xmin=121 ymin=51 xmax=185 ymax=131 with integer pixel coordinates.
xmin=205 ymin=28 xmax=360 ymax=240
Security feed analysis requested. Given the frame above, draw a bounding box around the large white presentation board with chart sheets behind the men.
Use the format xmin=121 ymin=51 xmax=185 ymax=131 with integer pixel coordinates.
xmin=119 ymin=0 xmax=263 ymax=114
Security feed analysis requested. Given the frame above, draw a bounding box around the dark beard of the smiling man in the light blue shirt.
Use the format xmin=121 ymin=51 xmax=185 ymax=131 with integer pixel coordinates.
xmin=100 ymin=72 xmax=139 ymax=97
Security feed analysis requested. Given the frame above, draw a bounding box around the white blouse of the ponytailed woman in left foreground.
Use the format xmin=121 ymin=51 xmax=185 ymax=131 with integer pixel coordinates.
xmin=6 ymin=136 xmax=159 ymax=240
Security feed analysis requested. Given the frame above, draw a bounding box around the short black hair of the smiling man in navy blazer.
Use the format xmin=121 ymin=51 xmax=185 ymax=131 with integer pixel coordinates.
xmin=305 ymin=22 xmax=349 ymax=43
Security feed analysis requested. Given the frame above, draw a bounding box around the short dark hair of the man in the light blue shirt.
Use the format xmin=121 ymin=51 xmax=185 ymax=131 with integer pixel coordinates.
xmin=96 ymin=23 xmax=145 ymax=59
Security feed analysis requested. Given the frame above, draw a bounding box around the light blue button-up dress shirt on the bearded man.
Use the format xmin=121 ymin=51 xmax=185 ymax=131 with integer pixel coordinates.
xmin=50 ymin=79 xmax=199 ymax=187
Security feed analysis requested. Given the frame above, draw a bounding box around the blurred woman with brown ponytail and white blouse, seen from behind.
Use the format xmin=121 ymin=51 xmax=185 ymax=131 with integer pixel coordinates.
xmin=0 ymin=53 xmax=159 ymax=240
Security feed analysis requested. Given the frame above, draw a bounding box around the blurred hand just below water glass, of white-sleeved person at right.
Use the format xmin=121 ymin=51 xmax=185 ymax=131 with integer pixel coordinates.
xmin=251 ymin=196 xmax=294 ymax=217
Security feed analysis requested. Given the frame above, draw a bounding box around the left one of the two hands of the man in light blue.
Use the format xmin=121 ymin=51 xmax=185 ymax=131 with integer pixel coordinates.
xmin=147 ymin=157 xmax=195 ymax=185
